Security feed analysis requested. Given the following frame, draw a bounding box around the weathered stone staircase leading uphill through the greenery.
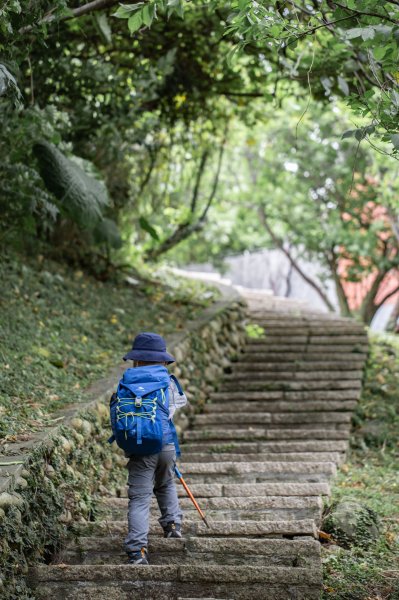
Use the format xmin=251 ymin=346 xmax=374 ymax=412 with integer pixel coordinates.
xmin=33 ymin=298 xmax=367 ymax=600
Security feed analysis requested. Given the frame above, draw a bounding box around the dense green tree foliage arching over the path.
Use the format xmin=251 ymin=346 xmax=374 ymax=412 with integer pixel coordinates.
xmin=0 ymin=0 xmax=399 ymax=322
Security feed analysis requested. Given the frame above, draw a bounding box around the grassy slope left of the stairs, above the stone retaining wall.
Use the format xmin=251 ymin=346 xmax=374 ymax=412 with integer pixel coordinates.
xmin=0 ymin=255 xmax=216 ymax=441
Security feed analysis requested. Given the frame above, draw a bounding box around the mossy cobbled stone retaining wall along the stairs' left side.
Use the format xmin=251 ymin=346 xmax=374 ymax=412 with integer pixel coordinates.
xmin=0 ymin=290 xmax=245 ymax=600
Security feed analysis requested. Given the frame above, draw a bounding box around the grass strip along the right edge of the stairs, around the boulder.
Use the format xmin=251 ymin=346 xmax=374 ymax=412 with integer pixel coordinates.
xmin=323 ymin=336 xmax=399 ymax=600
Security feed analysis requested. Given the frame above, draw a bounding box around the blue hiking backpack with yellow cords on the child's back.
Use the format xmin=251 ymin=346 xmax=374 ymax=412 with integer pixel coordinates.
xmin=108 ymin=365 xmax=183 ymax=456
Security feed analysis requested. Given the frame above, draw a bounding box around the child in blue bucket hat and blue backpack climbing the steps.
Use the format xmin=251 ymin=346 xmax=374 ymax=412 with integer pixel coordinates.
xmin=109 ymin=333 xmax=187 ymax=565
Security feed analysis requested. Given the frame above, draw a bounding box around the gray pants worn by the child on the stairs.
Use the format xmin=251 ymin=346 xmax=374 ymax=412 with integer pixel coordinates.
xmin=125 ymin=444 xmax=182 ymax=552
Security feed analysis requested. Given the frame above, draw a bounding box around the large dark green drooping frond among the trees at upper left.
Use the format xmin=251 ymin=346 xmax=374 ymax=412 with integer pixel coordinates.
xmin=33 ymin=142 xmax=110 ymax=230
